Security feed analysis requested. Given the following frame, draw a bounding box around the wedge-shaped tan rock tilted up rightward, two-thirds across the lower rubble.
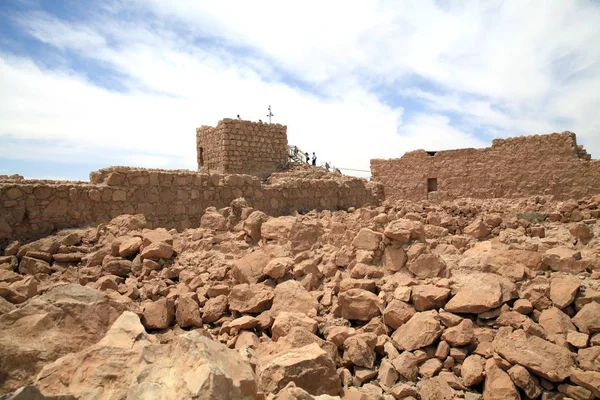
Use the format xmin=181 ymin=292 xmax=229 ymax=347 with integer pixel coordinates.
xmin=392 ymin=310 xmax=443 ymax=351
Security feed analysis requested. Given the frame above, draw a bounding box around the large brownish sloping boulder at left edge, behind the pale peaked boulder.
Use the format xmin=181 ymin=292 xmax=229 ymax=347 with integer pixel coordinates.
xmin=0 ymin=284 xmax=126 ymax=394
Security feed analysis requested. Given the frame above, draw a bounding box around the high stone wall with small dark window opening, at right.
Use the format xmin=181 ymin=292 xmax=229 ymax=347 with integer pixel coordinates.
xmin=371 ymin=132 xmax=600 ymax=201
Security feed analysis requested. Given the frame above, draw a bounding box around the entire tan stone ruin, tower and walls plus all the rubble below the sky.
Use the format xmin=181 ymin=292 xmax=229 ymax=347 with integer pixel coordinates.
xmin=0 ymin=120 xmax=600 ymax=400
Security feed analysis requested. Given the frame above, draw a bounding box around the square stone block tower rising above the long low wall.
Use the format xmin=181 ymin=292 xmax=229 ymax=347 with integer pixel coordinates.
xmin=196 ymin=119 xmax=288 ymax=176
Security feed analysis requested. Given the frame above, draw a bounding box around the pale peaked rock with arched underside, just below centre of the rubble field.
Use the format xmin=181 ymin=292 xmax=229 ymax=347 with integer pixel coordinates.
xmin=269 ymin=280 xmax=319 ymax=317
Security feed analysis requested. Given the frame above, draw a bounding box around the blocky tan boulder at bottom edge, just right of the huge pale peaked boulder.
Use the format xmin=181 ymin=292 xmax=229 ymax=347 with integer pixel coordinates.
xmin=256 ymin=343 xmax=341 ymax=396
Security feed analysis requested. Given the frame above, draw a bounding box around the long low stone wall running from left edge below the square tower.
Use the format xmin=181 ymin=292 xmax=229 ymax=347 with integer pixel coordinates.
xmin=0 ymin=167 xmax=383 ymax=239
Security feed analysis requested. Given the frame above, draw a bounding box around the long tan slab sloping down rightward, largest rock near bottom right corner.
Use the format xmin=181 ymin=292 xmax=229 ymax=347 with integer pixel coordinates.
xmin=493 ymin=330 xmax=575 ymax=382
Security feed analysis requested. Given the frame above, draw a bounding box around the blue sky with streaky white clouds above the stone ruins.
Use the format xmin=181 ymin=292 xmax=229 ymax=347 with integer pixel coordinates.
xmin=0 ymin=0 xmax=600 ymax=179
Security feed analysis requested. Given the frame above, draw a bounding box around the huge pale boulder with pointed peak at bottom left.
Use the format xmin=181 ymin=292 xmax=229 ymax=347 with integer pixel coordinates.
xmin=35 ymin=312 xmax=257 ymax=400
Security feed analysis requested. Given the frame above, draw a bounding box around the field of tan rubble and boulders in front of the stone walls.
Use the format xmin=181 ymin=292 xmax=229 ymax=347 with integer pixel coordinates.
xmin=0 ymin=195 xmax=600 ymax=400
